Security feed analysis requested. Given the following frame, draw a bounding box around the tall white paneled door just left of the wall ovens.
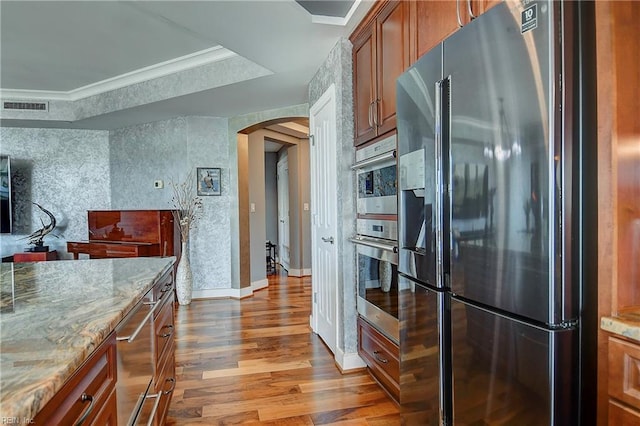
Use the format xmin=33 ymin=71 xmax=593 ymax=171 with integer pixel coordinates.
xmin=309 ymin=85 xmax=338 ymax=354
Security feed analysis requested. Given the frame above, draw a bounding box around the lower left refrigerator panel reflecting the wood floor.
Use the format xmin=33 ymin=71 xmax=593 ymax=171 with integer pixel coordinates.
xmin=398 ymin=275 xmax=448 ymax=426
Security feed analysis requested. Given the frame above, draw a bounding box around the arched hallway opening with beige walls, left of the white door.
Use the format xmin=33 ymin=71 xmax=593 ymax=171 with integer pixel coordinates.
xmin=237 ymin=117 xmax=311 ymax=296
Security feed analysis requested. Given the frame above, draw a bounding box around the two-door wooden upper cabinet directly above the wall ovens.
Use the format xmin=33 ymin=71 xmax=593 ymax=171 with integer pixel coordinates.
xmin=351 ymin=1 xmax=409 ymax=145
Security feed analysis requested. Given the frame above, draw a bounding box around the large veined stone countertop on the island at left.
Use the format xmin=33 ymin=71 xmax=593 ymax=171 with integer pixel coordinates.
xmin=0 ymin=257 xmax=175 ymax=420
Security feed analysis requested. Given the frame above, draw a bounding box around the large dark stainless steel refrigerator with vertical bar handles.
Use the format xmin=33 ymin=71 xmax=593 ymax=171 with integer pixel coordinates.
xmin=397 ymin=1 xmax=595 ymax=425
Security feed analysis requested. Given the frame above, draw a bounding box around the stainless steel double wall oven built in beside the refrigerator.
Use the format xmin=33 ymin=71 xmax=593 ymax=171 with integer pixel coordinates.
xmin=351 ymin=134 xmax=399 ymax=343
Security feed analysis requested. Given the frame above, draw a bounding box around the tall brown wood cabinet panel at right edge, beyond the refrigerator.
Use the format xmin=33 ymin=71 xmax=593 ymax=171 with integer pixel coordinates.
xmin=598 ymin=2 xmax=640 ymax=314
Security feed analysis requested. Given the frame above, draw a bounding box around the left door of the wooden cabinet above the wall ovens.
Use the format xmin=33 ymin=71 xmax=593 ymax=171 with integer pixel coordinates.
xmin=353 ymin=24 xmax=377 ymax=145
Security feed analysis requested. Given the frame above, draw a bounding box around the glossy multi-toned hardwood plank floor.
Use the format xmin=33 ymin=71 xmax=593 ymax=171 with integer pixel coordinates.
xmin=166 ymin=274 xmax=400 ymax=425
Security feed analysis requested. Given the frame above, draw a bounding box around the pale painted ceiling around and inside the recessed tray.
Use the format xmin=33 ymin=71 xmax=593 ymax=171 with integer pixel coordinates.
xmin=0 ymin=0 xmax=372 ymax=129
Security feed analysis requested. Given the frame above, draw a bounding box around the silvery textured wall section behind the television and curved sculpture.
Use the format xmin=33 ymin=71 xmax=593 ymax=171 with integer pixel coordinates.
xmin=0 ymin=127 xmax=111 ymax=257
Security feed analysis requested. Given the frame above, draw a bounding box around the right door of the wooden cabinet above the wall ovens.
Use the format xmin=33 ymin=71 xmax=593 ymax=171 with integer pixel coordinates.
xmin=374 ymin=1 xmax=409 ymax=135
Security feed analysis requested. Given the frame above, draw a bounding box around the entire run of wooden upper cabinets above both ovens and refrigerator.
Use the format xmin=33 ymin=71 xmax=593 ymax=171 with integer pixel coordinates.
xmin=351 ymin=0 xmax=501 ymax=145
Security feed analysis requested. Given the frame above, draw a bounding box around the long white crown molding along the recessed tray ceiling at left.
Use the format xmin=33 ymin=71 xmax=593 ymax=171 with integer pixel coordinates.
xmin=0 ymin=46 xmax=237 ymax=101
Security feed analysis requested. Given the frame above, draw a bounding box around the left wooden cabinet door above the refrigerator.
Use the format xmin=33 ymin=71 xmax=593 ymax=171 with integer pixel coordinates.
xmin=411 ymin=0 xmax=469 ymax=62
